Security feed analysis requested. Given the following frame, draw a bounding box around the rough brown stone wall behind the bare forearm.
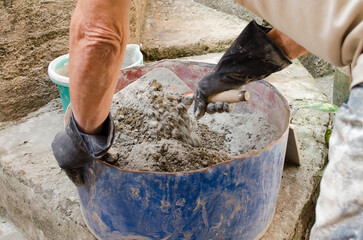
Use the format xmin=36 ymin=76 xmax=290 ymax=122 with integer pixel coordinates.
xmin=0 ymin=0 xmax=147 ymax=122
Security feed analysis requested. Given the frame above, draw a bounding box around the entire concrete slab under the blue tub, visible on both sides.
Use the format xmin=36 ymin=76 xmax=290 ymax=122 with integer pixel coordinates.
xmin=0 ymin=54 xmax=329 ymax=240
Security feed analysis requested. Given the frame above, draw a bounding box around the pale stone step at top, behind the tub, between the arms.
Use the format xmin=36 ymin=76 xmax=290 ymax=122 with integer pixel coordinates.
xmin=140 ymin=0 xmax=247 ymax=61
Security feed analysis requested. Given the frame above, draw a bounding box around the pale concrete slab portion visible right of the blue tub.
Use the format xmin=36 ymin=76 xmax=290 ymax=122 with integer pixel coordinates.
xmin=263 ymin=61 xmax=329 ymax=240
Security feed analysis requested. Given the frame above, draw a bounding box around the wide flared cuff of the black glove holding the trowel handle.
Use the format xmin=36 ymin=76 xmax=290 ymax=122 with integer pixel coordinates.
xmin=213 ymin=21 xmax=291 ymax=86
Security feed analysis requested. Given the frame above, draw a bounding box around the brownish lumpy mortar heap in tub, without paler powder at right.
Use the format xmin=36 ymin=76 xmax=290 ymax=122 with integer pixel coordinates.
xmin=104 ymin=74 xmax=231 ymax=172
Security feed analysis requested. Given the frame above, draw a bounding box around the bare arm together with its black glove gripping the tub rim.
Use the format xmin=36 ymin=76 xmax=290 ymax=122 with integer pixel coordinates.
xmin=52 ymin=0 xmax=130 ymax=186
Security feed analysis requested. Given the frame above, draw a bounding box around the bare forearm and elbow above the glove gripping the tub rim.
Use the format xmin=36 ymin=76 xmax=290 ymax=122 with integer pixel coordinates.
xmin=69 ymin=0 xmax=130 ymax=134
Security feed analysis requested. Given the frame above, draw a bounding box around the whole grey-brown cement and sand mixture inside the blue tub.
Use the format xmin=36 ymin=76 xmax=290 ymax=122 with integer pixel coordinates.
xmin=104 ymin=68 xmax=281 ymax=172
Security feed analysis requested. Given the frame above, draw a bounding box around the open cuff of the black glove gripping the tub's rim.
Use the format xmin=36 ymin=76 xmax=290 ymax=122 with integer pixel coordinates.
xmin=66 ymin=112 xmax=115 ymax=158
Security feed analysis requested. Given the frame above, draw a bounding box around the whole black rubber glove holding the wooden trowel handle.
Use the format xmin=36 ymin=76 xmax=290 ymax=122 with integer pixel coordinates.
xmin=194 ymin=21 xmax=291 ymax=119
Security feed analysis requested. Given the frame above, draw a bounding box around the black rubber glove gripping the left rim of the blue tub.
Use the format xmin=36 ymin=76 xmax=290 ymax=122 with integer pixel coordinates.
xmin=52 ymin=113 xmax=115 ymax=187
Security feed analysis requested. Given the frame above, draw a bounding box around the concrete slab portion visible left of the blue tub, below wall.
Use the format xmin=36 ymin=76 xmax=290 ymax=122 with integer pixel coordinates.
xmin=0 ymin=99 xmax=94 ymax=239
